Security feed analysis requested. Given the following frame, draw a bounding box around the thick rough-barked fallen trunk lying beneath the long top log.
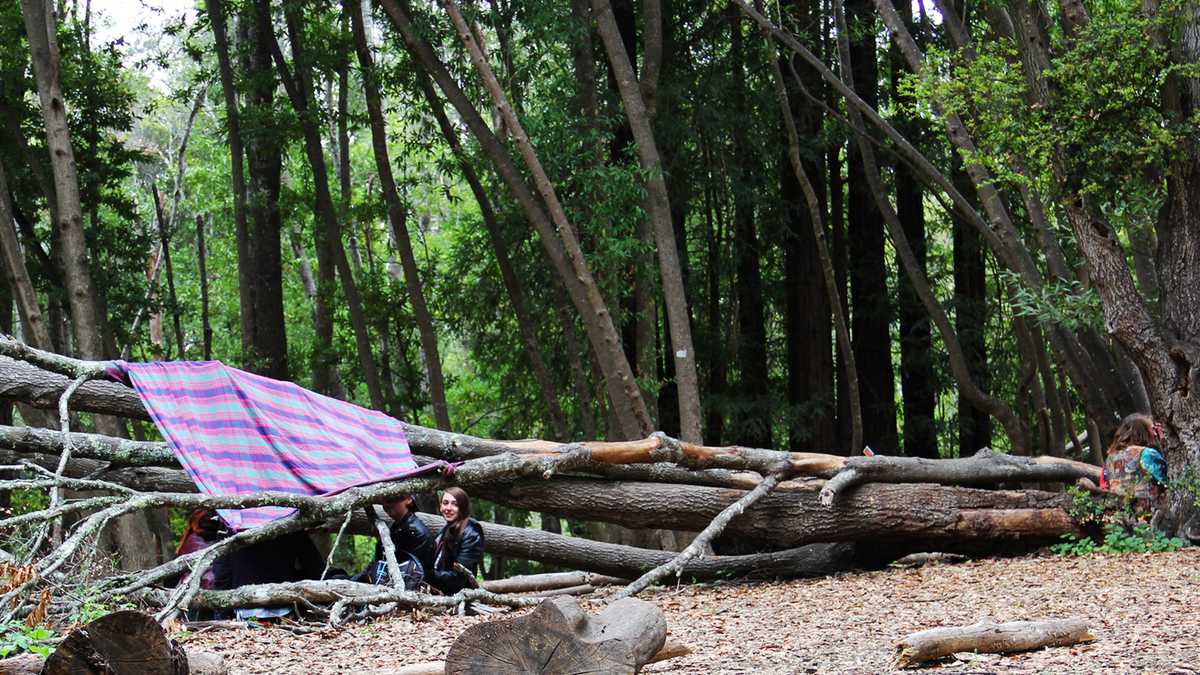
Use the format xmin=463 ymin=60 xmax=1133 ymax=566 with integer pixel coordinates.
xmin=472 ymin=478 xmax=1078 ymax=548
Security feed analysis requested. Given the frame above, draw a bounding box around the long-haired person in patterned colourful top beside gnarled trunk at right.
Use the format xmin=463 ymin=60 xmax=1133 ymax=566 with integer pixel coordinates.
xmin=1100 ymin=413 xmax=1166 ymax=519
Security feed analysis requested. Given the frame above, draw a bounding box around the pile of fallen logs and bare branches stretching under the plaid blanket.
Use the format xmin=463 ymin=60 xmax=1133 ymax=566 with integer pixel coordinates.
xmin=0 ymin=336 xmax=1099 ymax=623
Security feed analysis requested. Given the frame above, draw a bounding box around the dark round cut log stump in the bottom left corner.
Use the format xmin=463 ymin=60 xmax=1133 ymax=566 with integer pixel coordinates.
xmin=42 ymin=611 xmax=188 ymax=675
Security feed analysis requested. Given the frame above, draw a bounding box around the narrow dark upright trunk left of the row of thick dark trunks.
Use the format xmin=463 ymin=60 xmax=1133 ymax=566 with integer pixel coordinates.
xmin=727 ymin=6 xmax=773 ymax=448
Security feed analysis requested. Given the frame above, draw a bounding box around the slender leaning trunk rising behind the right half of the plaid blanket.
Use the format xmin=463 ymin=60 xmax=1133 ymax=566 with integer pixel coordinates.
xmin=270 ymin=2 xmax=384 ymax=410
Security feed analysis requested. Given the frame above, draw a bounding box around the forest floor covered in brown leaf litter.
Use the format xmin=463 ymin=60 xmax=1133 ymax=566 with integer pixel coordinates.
xmin=186 ymin=548 xmax=1200 ymax=675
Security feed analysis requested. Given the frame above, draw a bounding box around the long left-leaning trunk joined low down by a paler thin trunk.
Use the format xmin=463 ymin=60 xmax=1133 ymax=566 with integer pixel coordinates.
xmin=379 ymin=0 xmax=650 ymax=437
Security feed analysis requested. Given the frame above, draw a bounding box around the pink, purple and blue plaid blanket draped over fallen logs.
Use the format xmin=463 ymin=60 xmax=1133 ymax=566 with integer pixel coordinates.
xmin=109 ymin=362 xmax=444 ymax=530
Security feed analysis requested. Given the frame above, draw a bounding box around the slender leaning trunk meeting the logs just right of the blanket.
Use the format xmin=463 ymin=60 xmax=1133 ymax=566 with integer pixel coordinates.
xmin=346 ymin=0 xmax=450 ymax=430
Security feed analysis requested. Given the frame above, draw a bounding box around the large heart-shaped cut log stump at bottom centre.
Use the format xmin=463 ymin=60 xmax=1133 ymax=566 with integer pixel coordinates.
xmin=445 ymin=597 xmax=667 ymax=675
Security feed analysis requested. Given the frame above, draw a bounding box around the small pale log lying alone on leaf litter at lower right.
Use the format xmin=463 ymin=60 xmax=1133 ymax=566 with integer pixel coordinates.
xmin=893 ymin=619 xmax=1096 ymax=668
